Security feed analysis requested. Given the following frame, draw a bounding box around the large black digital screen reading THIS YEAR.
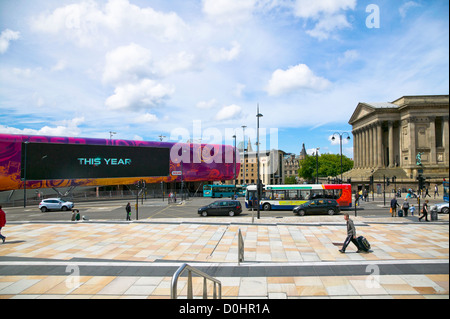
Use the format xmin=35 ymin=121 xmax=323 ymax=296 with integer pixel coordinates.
xmin=21 ymin=143 xmax=170 ymax=180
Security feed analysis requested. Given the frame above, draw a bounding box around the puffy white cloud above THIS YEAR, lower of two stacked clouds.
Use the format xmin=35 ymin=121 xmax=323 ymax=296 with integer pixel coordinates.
xmin=105 ymin=79 xmax=175 ymax=110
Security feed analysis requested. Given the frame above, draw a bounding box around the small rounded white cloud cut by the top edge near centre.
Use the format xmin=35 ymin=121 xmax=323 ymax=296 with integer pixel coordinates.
xmin=203 ymin=0 xmax=256 ymax=24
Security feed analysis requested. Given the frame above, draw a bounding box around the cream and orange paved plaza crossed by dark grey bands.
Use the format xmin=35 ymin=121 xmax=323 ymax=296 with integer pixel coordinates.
xmin=0 ymin=211 xmax=449 ymax=298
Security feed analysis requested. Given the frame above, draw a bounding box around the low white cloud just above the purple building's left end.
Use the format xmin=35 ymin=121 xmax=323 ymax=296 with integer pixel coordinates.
xmin=0 ymin=117 xmax=84 ymax=136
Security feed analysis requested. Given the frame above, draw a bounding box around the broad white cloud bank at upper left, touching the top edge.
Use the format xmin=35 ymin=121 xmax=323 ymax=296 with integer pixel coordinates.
xmin=31 ymin=0 xmax=187 ymax=46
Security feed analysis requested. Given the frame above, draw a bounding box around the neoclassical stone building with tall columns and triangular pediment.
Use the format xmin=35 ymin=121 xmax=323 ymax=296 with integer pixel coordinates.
xmin=345 ymin=95 xmax=449 ymax=184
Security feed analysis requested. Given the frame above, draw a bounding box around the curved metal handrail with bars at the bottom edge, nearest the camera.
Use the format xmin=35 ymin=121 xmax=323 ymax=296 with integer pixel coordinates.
xmin=170 ymin=264 xmax=222 ymax=299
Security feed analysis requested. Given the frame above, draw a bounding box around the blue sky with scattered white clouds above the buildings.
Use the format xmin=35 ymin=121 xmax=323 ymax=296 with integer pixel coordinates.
xmin=0 ymin=0 xmax=449 ymax=158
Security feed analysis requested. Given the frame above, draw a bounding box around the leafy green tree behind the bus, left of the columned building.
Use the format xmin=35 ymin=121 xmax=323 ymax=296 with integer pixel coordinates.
xmin=298 ymin=154 xmax=353 ymax=181
